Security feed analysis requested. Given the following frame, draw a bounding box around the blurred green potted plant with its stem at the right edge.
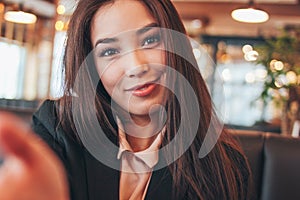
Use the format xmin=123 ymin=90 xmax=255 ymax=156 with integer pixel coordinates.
xmin=256 ymin=28 xmax=300 ymax=134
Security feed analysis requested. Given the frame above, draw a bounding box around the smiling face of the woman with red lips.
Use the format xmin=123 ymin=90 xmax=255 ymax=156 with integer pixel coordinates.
xmin=91 ymin=0 xmax=166 ymax=118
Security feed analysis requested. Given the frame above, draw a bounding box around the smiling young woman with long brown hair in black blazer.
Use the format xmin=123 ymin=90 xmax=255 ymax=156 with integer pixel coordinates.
xmin=0 ymin=0 xmax=250 ymax=200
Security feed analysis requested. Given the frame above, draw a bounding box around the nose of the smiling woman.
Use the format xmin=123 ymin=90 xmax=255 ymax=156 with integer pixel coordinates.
xmin=124 ymin=50 xmax=149 ymax=78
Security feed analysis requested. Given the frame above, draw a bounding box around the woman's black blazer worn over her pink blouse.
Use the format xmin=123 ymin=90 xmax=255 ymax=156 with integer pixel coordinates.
xmin=32 ymin=100 xmax=172 ymax=200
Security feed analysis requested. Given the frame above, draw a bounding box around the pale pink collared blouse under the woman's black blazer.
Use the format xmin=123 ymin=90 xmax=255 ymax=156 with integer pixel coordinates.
xmin=117 ymin=121 xmax=165 ymax=200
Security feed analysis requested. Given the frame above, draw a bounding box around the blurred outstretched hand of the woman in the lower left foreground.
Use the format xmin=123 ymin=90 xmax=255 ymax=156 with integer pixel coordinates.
xmin=0 ymin=113 xmax=69 ymax=200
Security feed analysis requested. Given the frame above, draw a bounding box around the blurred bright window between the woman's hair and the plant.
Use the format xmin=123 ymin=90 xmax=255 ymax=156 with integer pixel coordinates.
xmin=201 ymin=36 xmax=274 ymax=127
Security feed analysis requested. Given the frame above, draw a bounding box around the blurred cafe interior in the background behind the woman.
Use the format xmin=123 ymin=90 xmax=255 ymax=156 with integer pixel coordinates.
xmin=0 ymin=0 xmax=300 ymax=200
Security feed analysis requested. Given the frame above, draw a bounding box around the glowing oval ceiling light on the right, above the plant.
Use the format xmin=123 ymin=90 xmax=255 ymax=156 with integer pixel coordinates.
xmin=231 ymin=0 xmax=269 ymax=23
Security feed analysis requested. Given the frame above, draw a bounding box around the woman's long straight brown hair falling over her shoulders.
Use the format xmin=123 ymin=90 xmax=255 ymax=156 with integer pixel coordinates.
xmin=58 ymin=0 xmax=250 ymax=200
